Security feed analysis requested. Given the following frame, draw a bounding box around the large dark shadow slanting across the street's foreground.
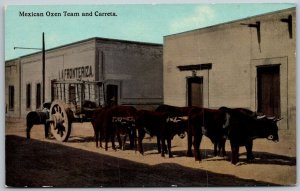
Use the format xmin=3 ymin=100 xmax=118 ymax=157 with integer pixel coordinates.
xmin=5 ymin=136 xmax=293 ymax=187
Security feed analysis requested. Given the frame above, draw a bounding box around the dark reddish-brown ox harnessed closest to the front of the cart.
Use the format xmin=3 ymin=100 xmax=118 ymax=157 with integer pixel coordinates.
xmin=92 ymin=106 xmax=136 ymax=150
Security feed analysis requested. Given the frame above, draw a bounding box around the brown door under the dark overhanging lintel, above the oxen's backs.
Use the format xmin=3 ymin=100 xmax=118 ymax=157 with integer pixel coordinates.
xmin=187 ymin=77 xmax=203 ymax=107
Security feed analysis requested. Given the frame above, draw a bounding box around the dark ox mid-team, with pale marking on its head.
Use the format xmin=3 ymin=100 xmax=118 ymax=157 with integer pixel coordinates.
xmin=136 ymin=110 xmax=185 ymax=158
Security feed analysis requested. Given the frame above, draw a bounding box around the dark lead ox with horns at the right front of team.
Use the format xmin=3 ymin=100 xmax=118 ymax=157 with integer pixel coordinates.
xmin=220 ymin=107 xmax=279 ymax=164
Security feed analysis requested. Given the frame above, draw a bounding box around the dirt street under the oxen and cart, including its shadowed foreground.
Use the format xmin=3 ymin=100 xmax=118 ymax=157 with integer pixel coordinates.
xmin=6 ymin=120 xmax=296 ymax=187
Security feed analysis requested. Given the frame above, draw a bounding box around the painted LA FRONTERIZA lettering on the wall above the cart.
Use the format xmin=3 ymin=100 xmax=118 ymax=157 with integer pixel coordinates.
xmin=59 ymin=66 xmax=93 ymax=80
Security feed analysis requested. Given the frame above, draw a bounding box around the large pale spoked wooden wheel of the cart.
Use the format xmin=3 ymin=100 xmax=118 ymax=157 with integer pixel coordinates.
xmin=50 ymin=100 xmax=73 ymax=141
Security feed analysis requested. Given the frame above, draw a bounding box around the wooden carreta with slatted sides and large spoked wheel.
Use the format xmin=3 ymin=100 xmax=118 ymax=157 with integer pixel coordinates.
xmin=48 ymin=81 xmax=106 ymax=141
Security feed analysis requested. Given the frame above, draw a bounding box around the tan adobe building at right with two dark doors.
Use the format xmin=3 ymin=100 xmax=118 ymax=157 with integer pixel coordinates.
xmin=163 ymin=8 xmax=296 ymax=129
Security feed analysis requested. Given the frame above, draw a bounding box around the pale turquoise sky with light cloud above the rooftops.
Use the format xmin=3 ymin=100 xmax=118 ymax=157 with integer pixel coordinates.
xmin=4 ymin=3 xmax=295 ymax=60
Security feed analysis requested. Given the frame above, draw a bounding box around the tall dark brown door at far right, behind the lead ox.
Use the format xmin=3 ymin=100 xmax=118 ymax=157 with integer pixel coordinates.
xmin=257 ymin=65 xmax=280 ymax=117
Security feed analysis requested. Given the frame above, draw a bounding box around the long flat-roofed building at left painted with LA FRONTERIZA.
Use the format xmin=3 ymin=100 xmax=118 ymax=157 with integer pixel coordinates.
xmin=5 ymin=38 xmax=163 ymax=117
